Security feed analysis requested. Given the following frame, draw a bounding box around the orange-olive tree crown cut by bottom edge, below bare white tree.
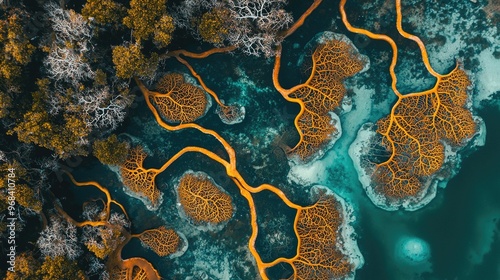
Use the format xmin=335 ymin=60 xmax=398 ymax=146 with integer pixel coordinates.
xmin=37 ymin=256 xmax=86 ymax=280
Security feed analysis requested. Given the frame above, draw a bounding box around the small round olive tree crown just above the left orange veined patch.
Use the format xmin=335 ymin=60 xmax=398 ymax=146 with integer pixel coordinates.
xmin=92 ymin=134 xmax=129 ymax=165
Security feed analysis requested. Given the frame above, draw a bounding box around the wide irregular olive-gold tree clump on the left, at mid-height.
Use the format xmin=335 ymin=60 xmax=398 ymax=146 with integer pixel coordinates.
xmin=9 ymin=79 xmax=90 ymax=158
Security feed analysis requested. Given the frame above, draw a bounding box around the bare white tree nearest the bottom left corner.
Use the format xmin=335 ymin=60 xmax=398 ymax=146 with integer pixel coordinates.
xmin=36 ymin=216 xmax=82 ymax=260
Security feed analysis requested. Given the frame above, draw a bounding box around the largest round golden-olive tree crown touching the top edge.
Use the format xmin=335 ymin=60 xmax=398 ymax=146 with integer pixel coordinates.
xmin=123 ymin=0 xmax=167 ymax=40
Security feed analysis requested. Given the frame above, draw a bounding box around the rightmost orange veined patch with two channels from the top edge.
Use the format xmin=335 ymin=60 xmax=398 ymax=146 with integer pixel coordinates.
xmin=340 ymin=0 xmax=476 ymax=201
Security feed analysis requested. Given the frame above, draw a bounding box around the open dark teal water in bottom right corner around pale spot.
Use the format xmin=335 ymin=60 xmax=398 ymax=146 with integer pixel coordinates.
xmin=357 ymin=109 xmax=500 ymax=279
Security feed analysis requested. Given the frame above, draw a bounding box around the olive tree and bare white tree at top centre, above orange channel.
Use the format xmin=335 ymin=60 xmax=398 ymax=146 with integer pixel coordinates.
xmin=174 ymin=0 xmax=293 ymax=57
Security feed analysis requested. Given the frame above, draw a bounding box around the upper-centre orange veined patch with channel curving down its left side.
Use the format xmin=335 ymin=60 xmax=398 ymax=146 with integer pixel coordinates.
xmin=273 ymin=39 xmax=364 ymax=161
